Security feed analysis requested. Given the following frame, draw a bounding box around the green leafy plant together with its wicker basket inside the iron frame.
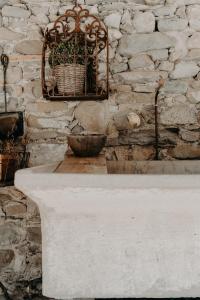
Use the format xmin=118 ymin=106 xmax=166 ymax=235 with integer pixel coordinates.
xmin=49 ymin=36 xmax=94 ymax=96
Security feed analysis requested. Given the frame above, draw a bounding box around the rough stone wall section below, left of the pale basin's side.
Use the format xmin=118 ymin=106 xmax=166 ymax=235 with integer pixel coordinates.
xmin=0 ymin=187 xmax=41 ymax=300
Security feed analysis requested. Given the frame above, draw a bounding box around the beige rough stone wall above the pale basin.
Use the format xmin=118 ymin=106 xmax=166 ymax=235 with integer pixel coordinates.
xmin=0 ymin=0 xmax=200 ymax=165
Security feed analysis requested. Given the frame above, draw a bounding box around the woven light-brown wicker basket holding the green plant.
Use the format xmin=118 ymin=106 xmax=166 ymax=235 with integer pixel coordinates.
xmin=54 ymin=64 xmax=85 ymax=95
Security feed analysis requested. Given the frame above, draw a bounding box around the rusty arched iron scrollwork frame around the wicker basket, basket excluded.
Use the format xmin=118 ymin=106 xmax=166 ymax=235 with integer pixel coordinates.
xmin=42 ymin=4 xmax=108 ymax=100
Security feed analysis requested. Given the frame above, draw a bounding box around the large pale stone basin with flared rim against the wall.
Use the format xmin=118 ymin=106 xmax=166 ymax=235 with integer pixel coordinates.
xmin=15 ymin=161 xmax=200 ymax=299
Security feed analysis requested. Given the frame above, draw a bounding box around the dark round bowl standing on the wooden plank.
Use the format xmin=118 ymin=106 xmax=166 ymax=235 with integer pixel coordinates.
xmin=67 ymin=134 xmax=106 ymax=157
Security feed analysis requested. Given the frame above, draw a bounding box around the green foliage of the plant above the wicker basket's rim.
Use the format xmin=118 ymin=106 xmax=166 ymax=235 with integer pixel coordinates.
xmin=49 ymin=40 xmax=85 ymax=68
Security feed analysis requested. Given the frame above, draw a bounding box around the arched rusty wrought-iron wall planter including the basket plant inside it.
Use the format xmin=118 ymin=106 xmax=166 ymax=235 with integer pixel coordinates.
xmin=42 ymin=3 xmax=109 ymax=100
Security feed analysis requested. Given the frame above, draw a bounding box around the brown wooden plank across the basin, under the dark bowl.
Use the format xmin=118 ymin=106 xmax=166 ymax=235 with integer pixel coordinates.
xmin=55 ymin=154 xmax=107 ymax=174
